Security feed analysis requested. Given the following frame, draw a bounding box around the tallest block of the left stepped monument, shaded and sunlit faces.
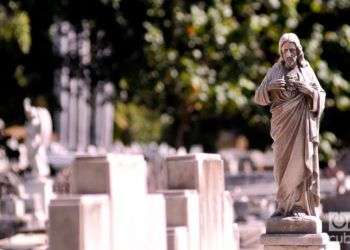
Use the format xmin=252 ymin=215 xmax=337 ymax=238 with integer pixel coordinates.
xmin=70 ymin=154 xmax=149 ymax=250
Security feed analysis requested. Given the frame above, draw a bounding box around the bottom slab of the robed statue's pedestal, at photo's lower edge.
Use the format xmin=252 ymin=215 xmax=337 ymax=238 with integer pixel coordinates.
xmin=260 ymin=233 xmax=340 ymax=250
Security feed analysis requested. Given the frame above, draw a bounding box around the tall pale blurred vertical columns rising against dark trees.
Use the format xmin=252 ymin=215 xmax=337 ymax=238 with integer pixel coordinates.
xmin=51 ymin=21 xmax=115 ymax=152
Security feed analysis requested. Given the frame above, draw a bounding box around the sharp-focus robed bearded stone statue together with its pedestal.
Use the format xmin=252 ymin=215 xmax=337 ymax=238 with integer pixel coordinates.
xmin=254 ymin=33 xmax=339 ymax=250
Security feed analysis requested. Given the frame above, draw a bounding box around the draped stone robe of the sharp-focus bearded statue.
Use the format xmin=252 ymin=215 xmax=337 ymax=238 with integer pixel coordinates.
xmin=254 ymin=62 xmax=326 ymax=215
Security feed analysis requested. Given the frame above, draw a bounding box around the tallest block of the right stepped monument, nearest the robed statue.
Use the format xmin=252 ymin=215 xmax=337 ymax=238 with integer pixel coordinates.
xmin=166 ymin=154 xmax=224 ymax=250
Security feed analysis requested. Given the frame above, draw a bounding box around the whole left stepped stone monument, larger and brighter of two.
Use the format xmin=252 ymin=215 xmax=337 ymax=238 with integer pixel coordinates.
xmin=49 ymin=154 xmax=167 ymax=250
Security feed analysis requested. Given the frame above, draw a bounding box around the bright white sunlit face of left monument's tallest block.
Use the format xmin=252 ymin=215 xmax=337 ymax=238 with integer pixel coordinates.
xmin=107 ymin=154 xmax=147 ymax=250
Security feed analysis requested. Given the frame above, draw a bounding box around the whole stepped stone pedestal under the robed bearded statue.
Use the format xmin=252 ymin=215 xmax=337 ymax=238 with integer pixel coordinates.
xmin=260 ymin=216 xmax=340 ymax=250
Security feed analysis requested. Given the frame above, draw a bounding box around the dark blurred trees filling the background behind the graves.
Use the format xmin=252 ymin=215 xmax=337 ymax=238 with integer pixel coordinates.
xmin=0 ymin=0 xmax=350 ymax=160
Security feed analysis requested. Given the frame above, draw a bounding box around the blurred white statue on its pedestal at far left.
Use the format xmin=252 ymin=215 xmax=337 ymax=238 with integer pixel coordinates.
xmin=23 ymin=99 xmax=54 ymax=229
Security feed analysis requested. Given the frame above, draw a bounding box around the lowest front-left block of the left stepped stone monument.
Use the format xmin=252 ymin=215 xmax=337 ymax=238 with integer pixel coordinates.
xmin=49 ymin=195 xmax=111 ymax=250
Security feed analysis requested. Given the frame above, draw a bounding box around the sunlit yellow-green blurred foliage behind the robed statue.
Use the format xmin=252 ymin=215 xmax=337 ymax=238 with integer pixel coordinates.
xmin=139 ymin=0 xmax=350 ymax=152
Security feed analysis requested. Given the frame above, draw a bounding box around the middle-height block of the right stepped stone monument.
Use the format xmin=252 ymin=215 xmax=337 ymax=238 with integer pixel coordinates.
xmin=160 ymin=190 xmax=199 ymax=250
